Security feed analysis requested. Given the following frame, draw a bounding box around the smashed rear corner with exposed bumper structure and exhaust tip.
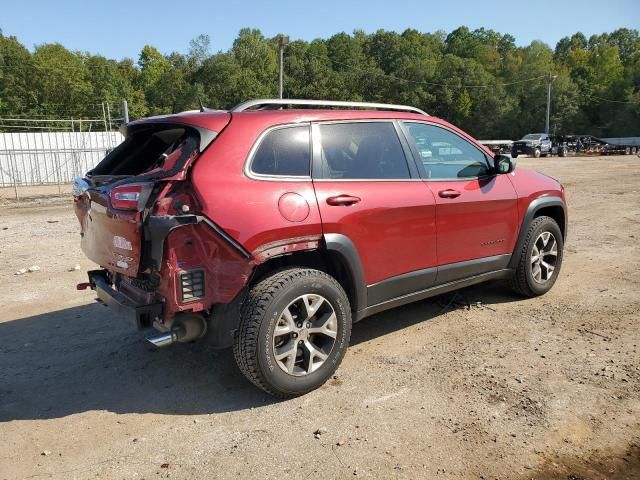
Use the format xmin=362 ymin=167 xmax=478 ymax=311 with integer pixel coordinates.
xmin=77 ymin=215 xmax=255 ymax=348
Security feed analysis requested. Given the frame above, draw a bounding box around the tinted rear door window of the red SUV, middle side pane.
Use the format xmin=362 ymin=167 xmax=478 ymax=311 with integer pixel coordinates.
xmin=314 ymin=122 xmax=411 ymax=180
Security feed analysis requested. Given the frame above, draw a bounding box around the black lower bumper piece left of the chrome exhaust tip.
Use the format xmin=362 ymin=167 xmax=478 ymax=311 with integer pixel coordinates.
xmin=88 ymin=270 xmax=162 ymax=330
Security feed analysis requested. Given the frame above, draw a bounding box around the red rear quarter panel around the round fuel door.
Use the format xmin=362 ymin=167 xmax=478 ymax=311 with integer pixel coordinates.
xmin=191 ymin=112 xmax=322 ymax=252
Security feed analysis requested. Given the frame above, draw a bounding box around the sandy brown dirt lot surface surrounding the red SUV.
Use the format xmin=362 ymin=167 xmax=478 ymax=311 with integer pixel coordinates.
xmin=0 ymin=156 xmax=640 ymax=480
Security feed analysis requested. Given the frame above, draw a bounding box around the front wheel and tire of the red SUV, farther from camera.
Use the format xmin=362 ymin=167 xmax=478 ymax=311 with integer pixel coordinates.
xmin=510 ymin=216 xmax=564 ymax=297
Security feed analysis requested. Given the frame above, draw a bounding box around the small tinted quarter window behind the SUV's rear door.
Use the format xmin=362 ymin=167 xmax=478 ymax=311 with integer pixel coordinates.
xmin=251 ymin=125 xmax=311 ymax=177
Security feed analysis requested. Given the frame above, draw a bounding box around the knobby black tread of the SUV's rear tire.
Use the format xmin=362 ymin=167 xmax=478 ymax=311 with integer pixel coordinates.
xmin=233 ymin=267 xmax=342 ymax=399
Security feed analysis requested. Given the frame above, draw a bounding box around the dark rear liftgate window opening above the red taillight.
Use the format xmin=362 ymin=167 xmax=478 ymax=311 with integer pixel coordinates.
xmin=89 ymin=126 xmax=200 ymax=176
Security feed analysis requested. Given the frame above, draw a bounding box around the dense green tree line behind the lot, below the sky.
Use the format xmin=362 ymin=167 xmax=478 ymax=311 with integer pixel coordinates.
xmin=0 ymin=27 xmax=640 ymax=139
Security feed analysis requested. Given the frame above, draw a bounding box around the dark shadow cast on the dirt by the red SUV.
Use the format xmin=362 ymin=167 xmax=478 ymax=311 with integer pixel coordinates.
xmin=0 ymin=284 xmax=518 ymax=422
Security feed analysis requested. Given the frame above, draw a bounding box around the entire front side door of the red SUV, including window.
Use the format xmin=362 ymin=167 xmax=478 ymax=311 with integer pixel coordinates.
xmin=403 ymin=122 xmax=518 ymax=283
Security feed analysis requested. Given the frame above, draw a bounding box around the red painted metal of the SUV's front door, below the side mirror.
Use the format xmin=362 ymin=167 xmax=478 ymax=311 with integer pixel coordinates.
xmin=425 ymin=175 xmax=518 ymax=265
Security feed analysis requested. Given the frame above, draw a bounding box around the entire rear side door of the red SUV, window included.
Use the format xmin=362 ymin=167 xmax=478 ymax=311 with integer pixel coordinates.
xmin=312 ymin=121 xmax=436 ymax=305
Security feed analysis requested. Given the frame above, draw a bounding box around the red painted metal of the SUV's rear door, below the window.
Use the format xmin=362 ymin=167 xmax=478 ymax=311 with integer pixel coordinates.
xmin=315 ymin=181 xmax=437 ymax=285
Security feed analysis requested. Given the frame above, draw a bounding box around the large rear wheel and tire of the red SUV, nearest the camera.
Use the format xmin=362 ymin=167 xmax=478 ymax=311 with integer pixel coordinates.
xmin=233 ymin=268 xmax=351 ymax=398
